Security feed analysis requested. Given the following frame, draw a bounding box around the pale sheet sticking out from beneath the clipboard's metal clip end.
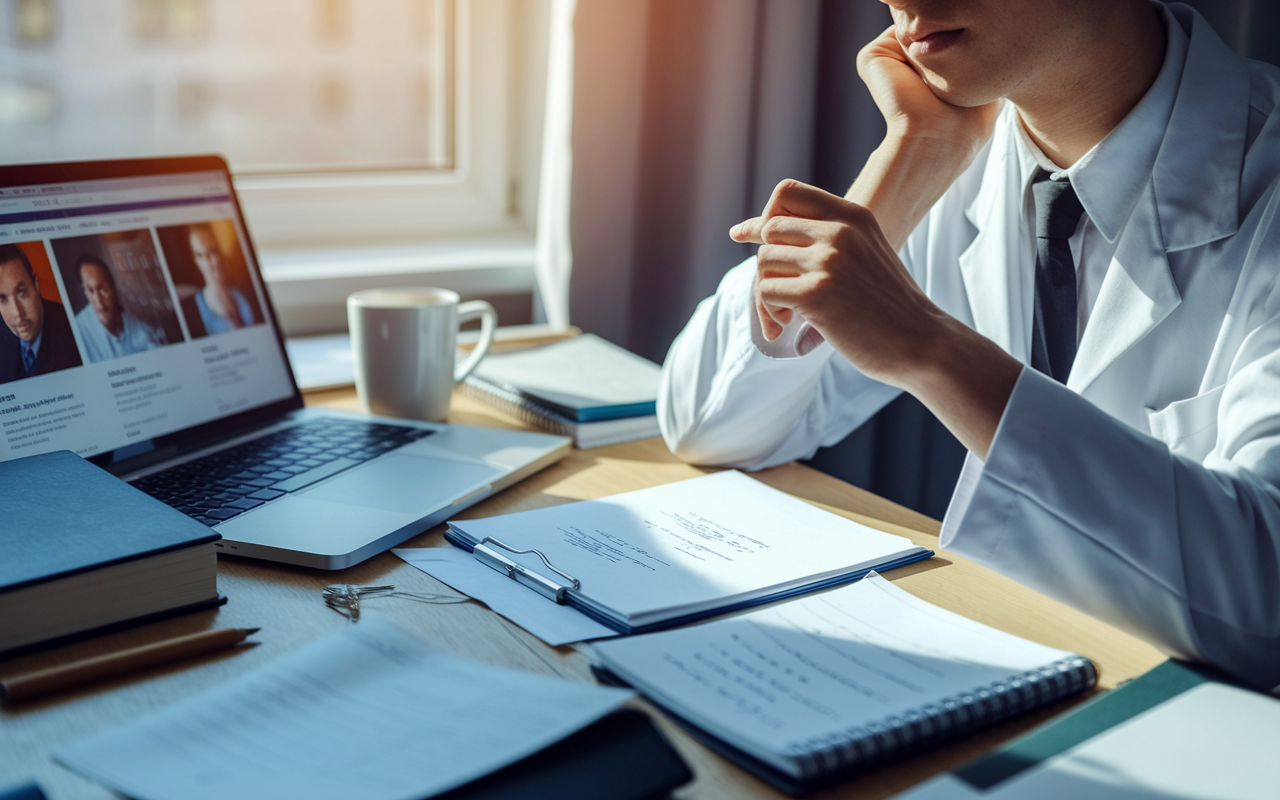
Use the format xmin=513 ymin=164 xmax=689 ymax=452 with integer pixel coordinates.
xmin=392 ymin=547 xmax=618 ymax=646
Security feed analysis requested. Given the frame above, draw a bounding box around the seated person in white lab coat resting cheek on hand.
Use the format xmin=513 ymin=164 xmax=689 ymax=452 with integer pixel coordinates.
xmin=658 ymin=0 xmax=1280 ymax=690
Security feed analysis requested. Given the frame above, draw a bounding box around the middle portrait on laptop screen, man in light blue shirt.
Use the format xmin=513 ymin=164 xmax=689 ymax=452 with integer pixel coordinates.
xmin=51 ymin=230 xmax=183 ymax=364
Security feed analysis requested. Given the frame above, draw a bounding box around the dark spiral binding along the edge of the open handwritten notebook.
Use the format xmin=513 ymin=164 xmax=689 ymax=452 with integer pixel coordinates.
xmin=788 ymin=655 xmax=1098 ymax=780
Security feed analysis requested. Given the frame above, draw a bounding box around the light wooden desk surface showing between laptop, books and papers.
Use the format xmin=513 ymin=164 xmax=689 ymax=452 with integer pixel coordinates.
xmin=0 ymin=390 xmax=1162 ymax=800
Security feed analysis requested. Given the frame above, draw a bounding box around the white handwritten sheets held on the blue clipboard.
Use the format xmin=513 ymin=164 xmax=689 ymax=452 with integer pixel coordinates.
xmin=451 ymin=471 xmax=923 ymax=623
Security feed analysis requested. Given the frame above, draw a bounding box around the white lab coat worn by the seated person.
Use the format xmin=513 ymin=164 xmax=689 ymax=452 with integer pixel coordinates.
xmin=658 ymin=5 xmax=1280 ymax=689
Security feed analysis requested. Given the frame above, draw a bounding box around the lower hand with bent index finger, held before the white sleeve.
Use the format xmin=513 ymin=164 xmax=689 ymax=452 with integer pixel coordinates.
xmin=730 ymin=180 xmax=951 ymax=388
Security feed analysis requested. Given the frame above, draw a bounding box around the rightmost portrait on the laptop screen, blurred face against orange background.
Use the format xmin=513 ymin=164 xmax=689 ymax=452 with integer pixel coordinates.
xmin=156 ymin=219 xmax=262 ymax=339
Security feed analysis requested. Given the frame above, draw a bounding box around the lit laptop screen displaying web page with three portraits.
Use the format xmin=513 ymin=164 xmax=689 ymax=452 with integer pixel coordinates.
xmin=0 ymin=159 xmax=297 ymax=462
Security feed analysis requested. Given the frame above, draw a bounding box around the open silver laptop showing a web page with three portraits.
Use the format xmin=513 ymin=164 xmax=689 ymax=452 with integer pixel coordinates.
xmin=0 ymin=156 xmax=570 ymax=570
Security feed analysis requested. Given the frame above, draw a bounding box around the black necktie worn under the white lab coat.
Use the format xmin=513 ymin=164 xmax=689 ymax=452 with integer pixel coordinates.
xmin=1032 ymin=169 xmax=1084 ymax=383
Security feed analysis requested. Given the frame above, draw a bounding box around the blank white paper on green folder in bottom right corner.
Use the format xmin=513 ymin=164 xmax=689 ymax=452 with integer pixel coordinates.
xmin=899 ymin=684 xmax=1280 ymax=800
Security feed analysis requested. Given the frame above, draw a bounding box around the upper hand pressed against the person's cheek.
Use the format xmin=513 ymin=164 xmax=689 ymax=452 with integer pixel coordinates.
xmin=858 ymin=26 xmax=1000 ymax=156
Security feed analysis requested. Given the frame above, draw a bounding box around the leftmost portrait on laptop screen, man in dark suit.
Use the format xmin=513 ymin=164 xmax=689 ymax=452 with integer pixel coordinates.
xmin=0 ymin=242 xmax=82 ymax=383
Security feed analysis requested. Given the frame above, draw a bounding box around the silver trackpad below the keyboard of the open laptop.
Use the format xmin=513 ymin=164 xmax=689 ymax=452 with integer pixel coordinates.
xmin=301 ymin=454 xmax=506 ymax=513
